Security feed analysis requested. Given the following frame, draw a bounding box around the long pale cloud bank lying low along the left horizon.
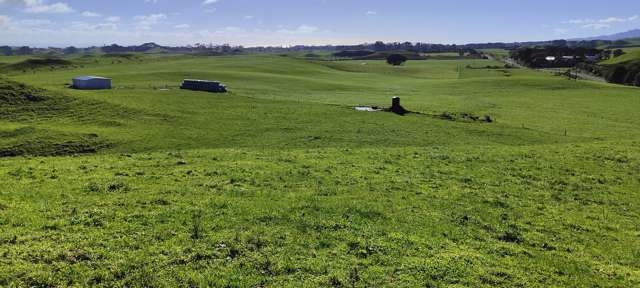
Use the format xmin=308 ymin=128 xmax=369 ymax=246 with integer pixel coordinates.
xmin=0 ymin=21 xmax=360 ymax=47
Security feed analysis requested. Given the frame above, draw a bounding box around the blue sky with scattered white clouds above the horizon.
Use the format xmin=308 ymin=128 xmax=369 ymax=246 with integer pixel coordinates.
xmin=0 ymin=0 xmax=640 ymax=46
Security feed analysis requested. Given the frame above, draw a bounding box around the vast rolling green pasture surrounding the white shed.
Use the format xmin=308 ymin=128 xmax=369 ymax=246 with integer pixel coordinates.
xmin=0 ymin=55 xmax=640 ymax=287
